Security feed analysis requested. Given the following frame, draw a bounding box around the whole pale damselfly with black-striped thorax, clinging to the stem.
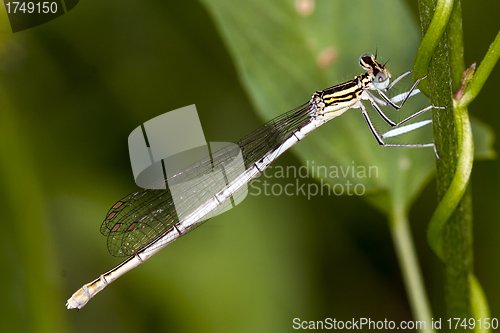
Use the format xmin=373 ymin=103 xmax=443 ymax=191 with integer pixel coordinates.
xmin=66 ymin=53 xmax=440 ymax=309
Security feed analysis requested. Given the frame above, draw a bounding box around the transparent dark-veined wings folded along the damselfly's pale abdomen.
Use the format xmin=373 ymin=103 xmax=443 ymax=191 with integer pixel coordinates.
xmin=101 ymin=103 xmax=311 ymax=257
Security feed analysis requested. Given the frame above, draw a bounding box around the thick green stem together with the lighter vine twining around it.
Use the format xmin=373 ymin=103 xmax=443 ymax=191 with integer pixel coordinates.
xmin=415 ymin=0 xmax=500 ymax=326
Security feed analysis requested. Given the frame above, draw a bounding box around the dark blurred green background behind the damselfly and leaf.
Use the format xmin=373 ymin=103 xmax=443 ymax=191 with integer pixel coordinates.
xmin=0 ymin=0 xmax=500 ymax=332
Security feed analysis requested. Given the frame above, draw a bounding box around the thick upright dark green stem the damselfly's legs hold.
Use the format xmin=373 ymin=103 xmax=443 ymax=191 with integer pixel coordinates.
xmin=416 ymin=0 xmax=473 ymax=324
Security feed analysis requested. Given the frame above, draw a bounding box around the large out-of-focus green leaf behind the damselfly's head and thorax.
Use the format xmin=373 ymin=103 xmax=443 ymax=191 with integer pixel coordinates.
xmin=202 ymin=0 xmax=434 ymax=212
